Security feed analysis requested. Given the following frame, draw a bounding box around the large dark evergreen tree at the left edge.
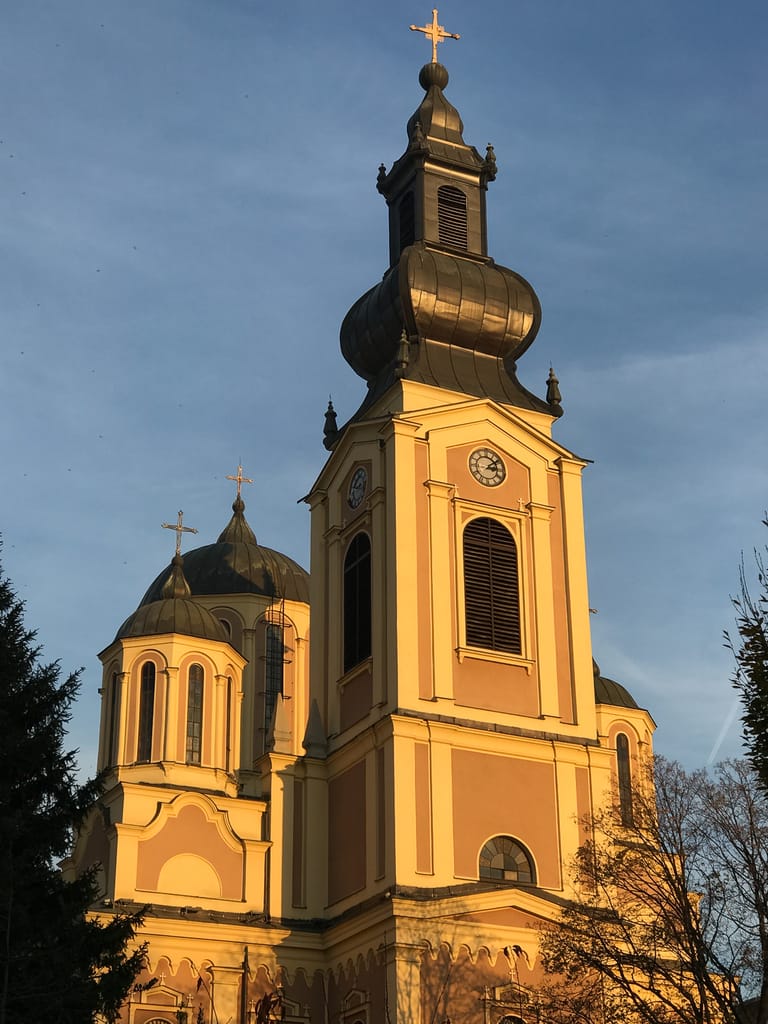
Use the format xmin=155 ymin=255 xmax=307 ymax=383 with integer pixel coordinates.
xmin=0 ymin=569 xmax=144 ymax=1024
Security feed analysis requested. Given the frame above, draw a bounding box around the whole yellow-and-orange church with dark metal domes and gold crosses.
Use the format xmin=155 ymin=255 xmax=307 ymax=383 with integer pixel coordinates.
xmin=65 ymin=11 xmax=654 ymax=1024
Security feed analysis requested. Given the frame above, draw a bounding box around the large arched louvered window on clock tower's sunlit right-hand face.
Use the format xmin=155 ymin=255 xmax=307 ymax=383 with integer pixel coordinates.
xmin=464 ymin=518 xmax=522 ymax=654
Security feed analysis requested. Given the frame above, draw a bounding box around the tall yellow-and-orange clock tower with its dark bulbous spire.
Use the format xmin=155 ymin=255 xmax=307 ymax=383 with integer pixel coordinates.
xmin=307 ymin=39 xmax=610 ymax=929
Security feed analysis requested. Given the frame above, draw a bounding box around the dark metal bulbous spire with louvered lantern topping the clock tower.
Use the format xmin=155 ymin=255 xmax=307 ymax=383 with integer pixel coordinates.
xmin=341 ymin=63 xmax=560 ymax=416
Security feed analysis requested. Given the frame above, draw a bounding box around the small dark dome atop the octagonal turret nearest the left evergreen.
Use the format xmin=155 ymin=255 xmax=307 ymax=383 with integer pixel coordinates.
xmin=115 ymin=555 xmax=228 ymax=643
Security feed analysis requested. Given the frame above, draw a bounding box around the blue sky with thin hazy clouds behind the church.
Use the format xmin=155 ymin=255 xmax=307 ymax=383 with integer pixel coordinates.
xmin=0 ymin=0 xmax=768 ymax=771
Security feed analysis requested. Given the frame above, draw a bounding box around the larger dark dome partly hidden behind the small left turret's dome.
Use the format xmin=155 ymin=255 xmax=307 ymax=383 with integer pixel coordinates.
xmin=141 ymin=496 xmax=309 ymax=606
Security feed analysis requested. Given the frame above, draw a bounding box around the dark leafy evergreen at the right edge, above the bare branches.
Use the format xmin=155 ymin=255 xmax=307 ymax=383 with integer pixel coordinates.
xmin=726 ymin=517 xmax=768 ymax=792
